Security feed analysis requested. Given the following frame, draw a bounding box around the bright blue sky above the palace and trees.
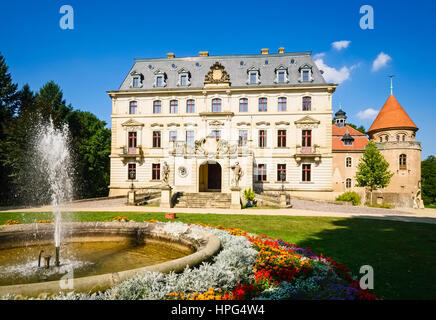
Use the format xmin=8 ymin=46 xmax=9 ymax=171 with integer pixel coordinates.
xmin=0 ymin=0 xmax=436 ymax=158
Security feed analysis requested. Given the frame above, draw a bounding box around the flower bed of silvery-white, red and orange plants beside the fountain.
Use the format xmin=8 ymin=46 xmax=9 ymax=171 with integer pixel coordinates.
xmin=3 ymin=217 xmax=375 ymax=300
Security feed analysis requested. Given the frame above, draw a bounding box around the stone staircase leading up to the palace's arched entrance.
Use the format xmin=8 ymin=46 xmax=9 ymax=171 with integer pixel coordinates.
xmin=174 ymin=192 xmax=231 ymax=209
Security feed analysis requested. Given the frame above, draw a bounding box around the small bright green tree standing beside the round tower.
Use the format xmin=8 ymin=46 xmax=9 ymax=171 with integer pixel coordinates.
xmin=356 ymin=141 xmax=393 ymax=202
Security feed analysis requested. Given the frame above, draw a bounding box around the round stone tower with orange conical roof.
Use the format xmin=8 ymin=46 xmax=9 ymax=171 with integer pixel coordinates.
xmin=368 ymin=94 xmax=422 ymax=207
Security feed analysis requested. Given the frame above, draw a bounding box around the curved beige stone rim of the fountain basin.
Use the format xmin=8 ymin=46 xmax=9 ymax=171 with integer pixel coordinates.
xmin=0 ymin=222 xmax=221 ymax=297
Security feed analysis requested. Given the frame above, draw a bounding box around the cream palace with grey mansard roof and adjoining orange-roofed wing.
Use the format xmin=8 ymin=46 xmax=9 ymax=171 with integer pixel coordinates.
xmin=108 ymin=48 xmax=420 ymax=207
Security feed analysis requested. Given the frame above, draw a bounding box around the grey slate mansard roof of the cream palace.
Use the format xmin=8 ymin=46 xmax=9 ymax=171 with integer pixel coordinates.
xmin=119 ymin=52 xmax=327 ymax=91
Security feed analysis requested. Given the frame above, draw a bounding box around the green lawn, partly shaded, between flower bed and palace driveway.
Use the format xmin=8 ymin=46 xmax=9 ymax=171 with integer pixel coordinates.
xmin=0 ymin=212 xmax=436 ymax=299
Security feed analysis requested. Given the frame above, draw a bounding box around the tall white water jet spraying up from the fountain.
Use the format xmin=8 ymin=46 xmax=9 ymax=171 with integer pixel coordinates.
xmin=34 ymin=119 xmax=73 ymax=267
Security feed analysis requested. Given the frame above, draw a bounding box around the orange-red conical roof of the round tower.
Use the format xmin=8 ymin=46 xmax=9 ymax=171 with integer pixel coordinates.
xmin=368 ymin=94 xmax=418 ymax=133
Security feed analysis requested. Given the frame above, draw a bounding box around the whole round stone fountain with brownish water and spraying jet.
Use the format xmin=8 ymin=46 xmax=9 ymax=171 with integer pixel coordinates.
xmin=0 ymin=121 xmax=220 ymax=297
